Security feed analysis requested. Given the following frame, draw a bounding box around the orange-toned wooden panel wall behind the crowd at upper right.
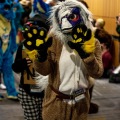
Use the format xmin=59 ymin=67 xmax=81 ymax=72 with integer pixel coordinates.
xmin=85 ymin=0 xmax=120 ymax=67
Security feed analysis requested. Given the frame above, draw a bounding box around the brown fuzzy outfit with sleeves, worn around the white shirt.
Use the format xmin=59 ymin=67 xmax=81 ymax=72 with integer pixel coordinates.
xmin=34 ymin=37 xmax=103 ymax=120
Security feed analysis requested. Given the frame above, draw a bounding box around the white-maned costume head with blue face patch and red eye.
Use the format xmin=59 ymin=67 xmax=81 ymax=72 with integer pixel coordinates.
xmin=49 ymin=0 xmax=92 ymax=43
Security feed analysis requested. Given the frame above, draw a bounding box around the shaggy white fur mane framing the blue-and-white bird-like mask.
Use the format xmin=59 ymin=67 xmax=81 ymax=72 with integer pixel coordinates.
xmin=49 ymin=0 xmax=92 ymax=42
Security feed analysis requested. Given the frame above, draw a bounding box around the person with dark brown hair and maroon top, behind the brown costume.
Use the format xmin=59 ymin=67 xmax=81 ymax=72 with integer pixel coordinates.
xmin=95 ymin=29 xmax=113 ymax=78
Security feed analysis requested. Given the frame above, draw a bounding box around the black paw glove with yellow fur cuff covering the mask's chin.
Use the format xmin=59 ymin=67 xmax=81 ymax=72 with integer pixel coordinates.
xmin=68 ymin=24 xmax=95 ymax=58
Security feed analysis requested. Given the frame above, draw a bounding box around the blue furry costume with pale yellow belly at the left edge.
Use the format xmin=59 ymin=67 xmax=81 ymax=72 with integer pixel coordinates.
xmin=0 ymin=0 xmax=18 ymax=98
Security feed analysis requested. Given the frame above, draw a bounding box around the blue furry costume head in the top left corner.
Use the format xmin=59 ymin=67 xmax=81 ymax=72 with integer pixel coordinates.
xmin=0 ymin=0 xmax=15 ymax=20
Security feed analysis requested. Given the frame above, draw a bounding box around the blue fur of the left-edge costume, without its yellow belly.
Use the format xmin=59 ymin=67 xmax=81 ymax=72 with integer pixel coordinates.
xmin=0 ymin=0 xmax=18 ymax=96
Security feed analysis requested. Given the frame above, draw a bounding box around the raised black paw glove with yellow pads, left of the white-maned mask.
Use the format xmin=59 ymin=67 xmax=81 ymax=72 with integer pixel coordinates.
xmin=23 ymin=20 xmax=52 ymax=61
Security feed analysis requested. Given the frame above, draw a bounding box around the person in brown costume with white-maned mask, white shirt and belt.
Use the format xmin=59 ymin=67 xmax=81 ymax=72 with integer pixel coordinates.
xmin=34 ymin=0 xmax=103 ymax=120
